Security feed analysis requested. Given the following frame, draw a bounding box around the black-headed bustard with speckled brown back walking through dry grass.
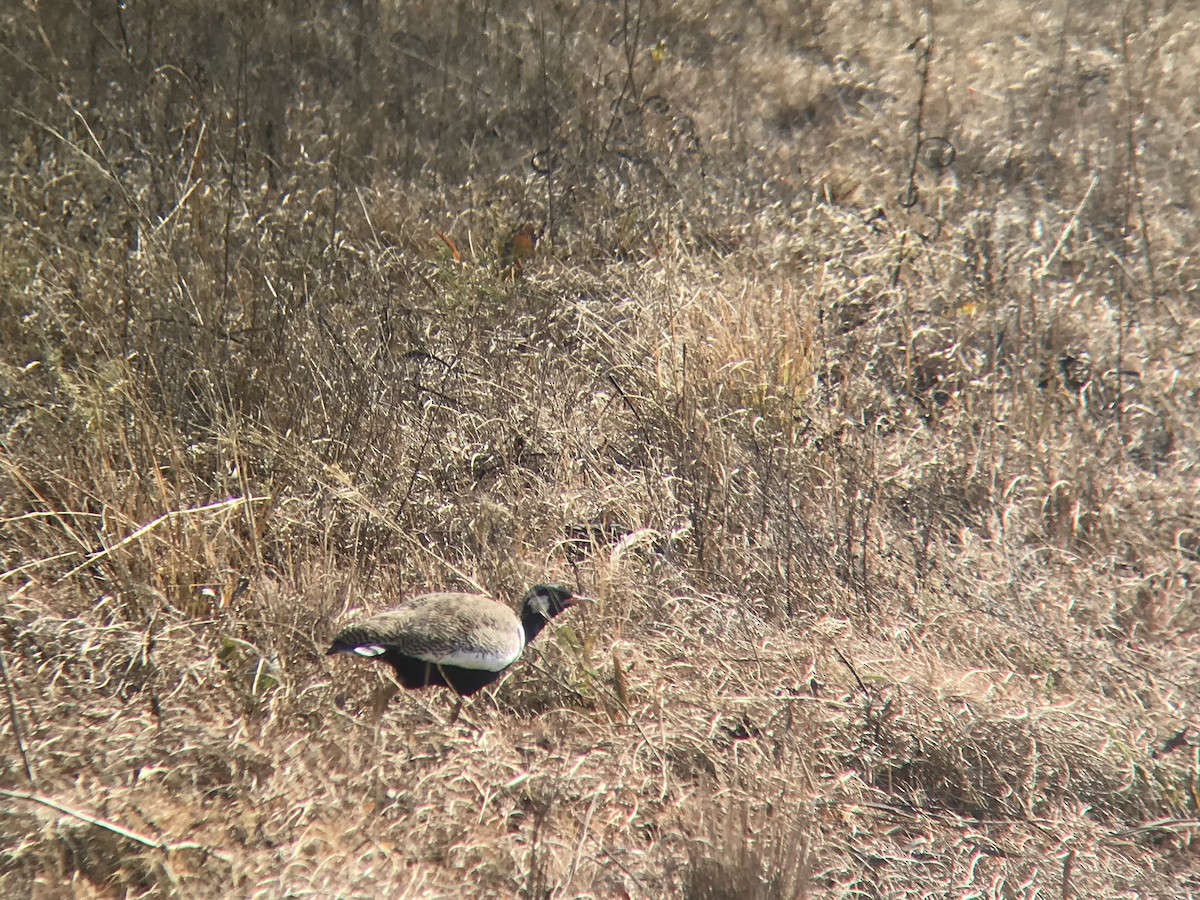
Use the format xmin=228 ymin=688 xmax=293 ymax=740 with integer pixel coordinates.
xmin=326 ymin=584 xmax=590 ymax=698
